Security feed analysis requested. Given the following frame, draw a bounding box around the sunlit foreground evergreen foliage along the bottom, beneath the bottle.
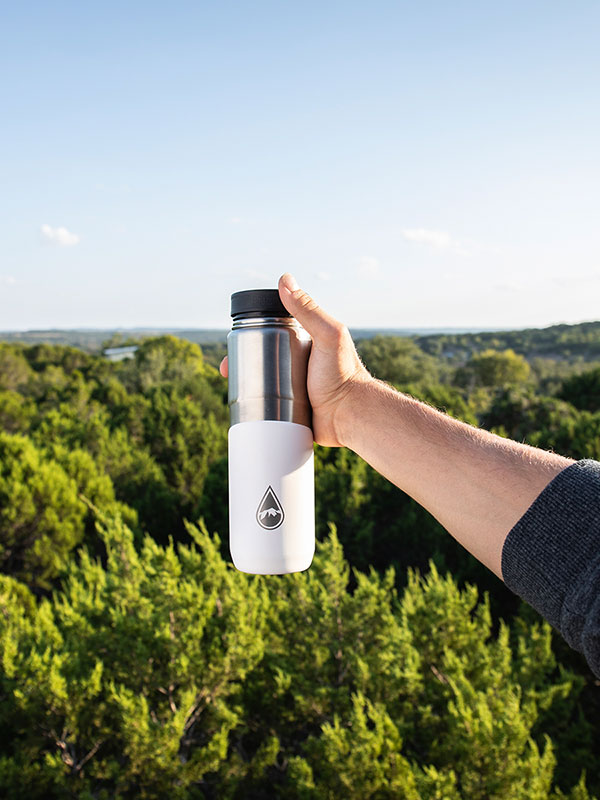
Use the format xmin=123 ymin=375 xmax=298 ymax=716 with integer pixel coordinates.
xmin=0 ymin=521 xmax=588 ymax=800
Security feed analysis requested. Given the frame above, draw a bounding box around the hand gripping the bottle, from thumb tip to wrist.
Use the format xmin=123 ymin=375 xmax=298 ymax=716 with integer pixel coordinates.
xmin=220 ymin=272 xmax=373 ymax=447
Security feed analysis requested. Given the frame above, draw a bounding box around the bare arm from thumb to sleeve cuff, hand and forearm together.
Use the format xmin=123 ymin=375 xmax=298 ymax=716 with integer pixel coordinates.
xmin=279 ymin=275 xmax=573 ymax=578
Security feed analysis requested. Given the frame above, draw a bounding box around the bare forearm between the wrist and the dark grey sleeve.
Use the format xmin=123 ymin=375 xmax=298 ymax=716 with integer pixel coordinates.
xmin=336 ymin=380 xmax=573 ymax=577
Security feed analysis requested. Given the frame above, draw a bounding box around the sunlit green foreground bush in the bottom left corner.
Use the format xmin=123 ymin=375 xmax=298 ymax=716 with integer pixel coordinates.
xmin=0 ymin=523 xmax=265 ymax=798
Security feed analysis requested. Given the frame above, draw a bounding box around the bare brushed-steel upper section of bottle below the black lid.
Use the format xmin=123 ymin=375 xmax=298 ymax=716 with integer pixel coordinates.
xmin=227 ymin=316 xmax=312 ymax=428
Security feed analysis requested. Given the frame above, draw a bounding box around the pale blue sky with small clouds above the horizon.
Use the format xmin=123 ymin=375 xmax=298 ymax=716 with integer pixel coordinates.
xmin=0 ymin=0 xmax=600 ymax=330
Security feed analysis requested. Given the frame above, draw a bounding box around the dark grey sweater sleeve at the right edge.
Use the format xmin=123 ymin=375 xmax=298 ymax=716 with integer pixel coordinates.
xmin=502 ymin=460 xmax=600 ymax=677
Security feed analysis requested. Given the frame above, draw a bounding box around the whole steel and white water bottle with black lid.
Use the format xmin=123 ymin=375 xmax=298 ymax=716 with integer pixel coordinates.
xmin=227 ymin=289 xmax=315 ymax=575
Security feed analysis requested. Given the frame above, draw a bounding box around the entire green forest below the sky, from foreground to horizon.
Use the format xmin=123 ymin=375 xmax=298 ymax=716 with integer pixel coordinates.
xmin=0 ymin=329 xmax=600 ymax=800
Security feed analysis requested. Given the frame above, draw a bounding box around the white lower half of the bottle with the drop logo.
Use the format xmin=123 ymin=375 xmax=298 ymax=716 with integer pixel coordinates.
xmin=229 ymin=420 xmax=315 ymax=575
